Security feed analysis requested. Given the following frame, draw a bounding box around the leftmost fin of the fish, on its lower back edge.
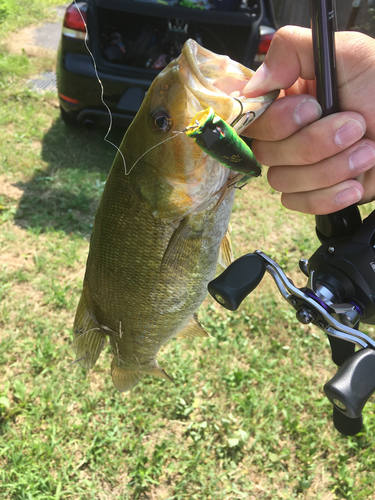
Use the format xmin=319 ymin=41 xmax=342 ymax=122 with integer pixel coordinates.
xmin=73 ymin=283 xmax=107 ymax=370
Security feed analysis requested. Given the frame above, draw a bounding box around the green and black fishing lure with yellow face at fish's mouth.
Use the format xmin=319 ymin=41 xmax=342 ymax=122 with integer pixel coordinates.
xmin=185 ymin=108 xmax=262 ymax=177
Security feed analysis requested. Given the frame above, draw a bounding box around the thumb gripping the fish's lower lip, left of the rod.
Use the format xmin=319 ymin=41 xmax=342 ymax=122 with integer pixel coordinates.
xmin=243 ymin=26 xmax=315 ymax=97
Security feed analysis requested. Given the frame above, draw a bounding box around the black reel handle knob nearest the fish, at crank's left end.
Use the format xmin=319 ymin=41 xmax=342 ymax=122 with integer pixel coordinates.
xmin=208 ymin=253 xmax=266 ymax=311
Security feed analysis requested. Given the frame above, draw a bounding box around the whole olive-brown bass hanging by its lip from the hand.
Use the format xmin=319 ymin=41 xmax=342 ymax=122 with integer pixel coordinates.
xmin=73 ymin=40 xmax=277 ymax=392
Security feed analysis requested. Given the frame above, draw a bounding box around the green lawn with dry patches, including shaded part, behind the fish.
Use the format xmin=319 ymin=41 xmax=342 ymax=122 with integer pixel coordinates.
xmin=0 ymin=2 xmax=375 ymax=500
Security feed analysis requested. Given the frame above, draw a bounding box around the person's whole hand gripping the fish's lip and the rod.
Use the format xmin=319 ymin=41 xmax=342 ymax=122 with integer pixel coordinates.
xmin=244 ymin=26 xmax=375 ymax=214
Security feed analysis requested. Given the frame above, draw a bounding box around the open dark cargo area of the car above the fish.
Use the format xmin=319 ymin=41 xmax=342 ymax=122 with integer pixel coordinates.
xmin=91 ymin=0 xmax=260 ymax=73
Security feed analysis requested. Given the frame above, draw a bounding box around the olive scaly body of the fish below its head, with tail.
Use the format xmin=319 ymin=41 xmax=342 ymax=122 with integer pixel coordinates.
xmin=74 ymin=160 xmax=234 ymax=390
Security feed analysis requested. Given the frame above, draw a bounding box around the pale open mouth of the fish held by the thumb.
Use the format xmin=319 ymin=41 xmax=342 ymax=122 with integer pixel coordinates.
xmin=177 ymin=39 xmax=279 ymax=132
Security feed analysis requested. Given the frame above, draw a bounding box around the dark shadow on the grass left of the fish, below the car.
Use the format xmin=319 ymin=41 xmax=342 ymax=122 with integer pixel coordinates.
xmin=15 ymin=118 xmax=125 ymax=236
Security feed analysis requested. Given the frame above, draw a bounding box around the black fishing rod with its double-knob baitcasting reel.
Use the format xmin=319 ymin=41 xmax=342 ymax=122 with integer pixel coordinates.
xmin=208 ymin=0 xmax=375 ymax=436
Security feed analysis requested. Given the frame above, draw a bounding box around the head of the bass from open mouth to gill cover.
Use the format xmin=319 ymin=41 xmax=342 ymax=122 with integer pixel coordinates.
xmin=121 ymin=39 xmax=278 ymax=220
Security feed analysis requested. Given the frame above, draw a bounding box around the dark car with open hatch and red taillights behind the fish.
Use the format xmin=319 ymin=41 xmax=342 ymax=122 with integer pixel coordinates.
xmin=57 ymin=0 xmax=276 ymax=126
